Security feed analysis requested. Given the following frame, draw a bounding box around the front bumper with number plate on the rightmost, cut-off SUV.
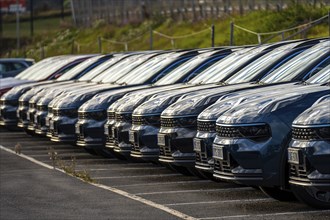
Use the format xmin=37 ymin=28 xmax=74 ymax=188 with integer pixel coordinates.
xmin=288 ymin=140 xmax=330 ymax=191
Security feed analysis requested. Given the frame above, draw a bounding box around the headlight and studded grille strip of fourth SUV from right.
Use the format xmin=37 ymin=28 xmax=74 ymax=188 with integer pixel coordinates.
xmin=161 ymin=116 xmax=197 ymax=128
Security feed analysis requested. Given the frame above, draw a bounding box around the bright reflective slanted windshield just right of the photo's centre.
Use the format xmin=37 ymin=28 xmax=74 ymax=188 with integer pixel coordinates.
xmin=155 ymin=52 xmax=222 ymax=85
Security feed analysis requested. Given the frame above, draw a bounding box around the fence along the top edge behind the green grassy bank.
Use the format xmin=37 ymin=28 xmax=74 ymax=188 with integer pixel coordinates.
xmin=71 ymin=0 xmax=330 ymax=26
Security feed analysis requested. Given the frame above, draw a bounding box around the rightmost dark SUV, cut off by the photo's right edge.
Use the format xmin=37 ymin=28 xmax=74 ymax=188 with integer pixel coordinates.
xmin=288 ymin=96 xmax=330 ymax=209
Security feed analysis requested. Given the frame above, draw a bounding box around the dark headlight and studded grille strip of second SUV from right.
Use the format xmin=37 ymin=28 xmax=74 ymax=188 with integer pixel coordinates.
xmin=216 ymin=124 xmax=271 ymax=141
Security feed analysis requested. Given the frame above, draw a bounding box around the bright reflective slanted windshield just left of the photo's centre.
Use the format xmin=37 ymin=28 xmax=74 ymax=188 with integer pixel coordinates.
xmin=116 ymin=53 xmax=177 ymax=85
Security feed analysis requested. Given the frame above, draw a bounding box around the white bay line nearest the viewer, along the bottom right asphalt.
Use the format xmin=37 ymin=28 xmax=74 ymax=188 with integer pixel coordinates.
xmin=198 ymin=210 xmax=330 ymax=220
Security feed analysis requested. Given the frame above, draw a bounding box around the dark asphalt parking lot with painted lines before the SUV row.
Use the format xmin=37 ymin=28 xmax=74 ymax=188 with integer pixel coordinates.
xmin=0 ymin=130 xmax=330 ymax=220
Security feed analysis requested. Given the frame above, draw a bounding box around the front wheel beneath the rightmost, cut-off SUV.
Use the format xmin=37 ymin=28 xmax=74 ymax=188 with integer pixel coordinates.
xmin=291 ymin=185 xmax=330 ymax=209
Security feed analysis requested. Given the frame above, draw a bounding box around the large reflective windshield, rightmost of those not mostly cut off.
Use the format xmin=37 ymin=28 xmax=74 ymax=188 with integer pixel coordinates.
xmin=261 ymin=42 xmax=329 ymax=84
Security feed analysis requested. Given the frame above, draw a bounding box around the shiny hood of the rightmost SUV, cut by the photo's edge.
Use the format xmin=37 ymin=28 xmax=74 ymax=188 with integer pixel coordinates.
xmin=293 ymin=95 xmax=330 ymax=126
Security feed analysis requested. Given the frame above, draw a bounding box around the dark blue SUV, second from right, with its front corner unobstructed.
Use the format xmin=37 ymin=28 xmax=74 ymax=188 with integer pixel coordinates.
xmin=213 ymin=67 xmax=330 ymax=200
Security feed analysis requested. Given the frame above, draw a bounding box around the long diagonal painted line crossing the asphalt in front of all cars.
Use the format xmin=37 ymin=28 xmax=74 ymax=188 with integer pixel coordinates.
xmin=0 ymin=145 xmax=197 ymax=220
